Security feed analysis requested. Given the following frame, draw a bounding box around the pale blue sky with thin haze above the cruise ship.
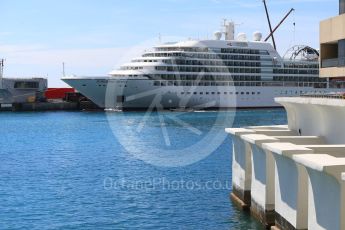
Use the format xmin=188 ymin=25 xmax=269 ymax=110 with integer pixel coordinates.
xmin=0 ymin=0 xmax=338 ymax=87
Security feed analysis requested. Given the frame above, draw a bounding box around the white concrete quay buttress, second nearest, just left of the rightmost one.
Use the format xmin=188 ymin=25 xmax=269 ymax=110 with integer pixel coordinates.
xmin=263 ymin=143 xmax=313 ymax=229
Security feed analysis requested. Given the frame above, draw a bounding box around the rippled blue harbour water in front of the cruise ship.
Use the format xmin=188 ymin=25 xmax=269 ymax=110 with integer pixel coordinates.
xmin=0 ymin=110 xmax=286 ymax=229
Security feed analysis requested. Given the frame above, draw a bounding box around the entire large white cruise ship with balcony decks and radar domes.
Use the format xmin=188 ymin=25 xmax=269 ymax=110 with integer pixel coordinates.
xmin=62 ymin=22 xmax=337 ymax=110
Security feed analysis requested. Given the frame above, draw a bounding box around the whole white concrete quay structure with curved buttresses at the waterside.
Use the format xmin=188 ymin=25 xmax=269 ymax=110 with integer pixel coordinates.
xmin=225 ymin=98 xmax=345 ymax=230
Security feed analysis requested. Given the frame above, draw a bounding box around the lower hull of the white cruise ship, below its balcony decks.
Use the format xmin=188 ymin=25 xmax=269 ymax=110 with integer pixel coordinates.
xmin=63 ymin=78 xmax=331 ymax=110
